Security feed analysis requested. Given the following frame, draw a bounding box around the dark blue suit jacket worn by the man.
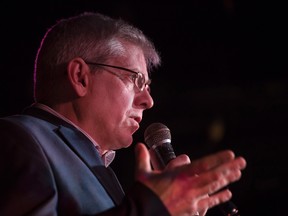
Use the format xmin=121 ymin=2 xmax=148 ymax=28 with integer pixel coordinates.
xmin=0 ymin=107 xmax=169 ymax=216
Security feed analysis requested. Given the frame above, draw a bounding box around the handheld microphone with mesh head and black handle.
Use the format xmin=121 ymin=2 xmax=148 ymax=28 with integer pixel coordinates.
xmin=144 ymin=122 xmax=240 ymax=216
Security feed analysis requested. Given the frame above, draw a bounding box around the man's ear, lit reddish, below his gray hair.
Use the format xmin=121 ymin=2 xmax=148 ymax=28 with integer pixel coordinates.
xmin=67 ymin=58 xmax=90 ymax=96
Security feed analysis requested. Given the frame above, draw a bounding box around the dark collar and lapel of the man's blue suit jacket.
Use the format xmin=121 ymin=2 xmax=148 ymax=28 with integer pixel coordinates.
xmin=25 ymin=107 xmax=124 ymax=204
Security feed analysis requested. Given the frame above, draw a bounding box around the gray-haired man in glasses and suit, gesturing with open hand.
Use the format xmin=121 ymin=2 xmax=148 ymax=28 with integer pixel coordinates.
xmin=0 ymin=13 xmax=246 ymax=216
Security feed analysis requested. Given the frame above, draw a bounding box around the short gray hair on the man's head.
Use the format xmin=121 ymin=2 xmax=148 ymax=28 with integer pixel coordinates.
xmin=34 ymin=12 xmax=160 ymax=101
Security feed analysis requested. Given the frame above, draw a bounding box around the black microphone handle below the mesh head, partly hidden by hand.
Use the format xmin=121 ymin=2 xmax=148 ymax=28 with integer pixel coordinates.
xmin=149 ymin=142 xmax=240 ymax=216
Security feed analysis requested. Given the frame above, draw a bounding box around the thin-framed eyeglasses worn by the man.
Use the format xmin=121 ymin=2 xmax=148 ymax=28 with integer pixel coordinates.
xmin=85 ymin=61 xmax=151 ymax=92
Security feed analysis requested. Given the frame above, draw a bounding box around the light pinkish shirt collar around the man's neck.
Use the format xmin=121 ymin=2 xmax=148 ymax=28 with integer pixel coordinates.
xmin=34 ymin=103 xmax=116 ymax=167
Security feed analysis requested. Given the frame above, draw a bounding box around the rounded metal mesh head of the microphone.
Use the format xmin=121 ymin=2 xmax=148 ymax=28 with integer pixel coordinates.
xmin=144 ymin=123 xmax=171 ymax=148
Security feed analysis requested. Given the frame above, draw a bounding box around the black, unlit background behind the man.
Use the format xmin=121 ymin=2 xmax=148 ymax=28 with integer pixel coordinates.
xmin=0 ymin=0 xmax=288 ymax=216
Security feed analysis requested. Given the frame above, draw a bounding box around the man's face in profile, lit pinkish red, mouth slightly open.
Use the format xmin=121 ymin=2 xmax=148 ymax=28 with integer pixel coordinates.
xmin=81 ymin=45 xmax=153 ymax=152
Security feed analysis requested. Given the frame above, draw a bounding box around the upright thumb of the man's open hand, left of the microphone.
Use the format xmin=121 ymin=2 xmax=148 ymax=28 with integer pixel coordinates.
xmin=135 ymin=143 xmax=152 ymax=180
